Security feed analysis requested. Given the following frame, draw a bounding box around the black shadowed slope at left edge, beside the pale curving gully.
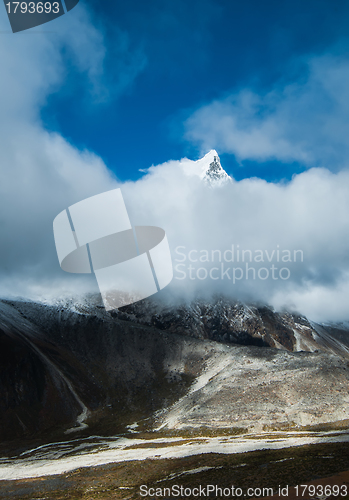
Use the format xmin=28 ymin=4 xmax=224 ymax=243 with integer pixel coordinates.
xmin=0 ymin=300 xmax=79 ymax=441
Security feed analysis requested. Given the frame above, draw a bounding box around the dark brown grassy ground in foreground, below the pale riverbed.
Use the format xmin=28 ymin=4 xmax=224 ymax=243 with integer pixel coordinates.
xmin=0 ymin=440 xmax=349 ymax=500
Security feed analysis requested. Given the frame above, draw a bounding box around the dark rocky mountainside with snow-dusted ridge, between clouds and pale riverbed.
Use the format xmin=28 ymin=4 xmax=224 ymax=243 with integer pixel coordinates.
xmin=0 ymin=296 xmax=349 ymax=446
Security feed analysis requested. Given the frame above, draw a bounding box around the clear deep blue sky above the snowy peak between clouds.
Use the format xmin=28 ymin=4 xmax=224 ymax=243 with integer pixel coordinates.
xmin=41 ymin=0 xmax=349 ymax=181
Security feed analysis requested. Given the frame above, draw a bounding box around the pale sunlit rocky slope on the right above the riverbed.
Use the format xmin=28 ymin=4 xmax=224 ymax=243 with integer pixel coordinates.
xmin=156 ymin=345 xmax=349 ymax=432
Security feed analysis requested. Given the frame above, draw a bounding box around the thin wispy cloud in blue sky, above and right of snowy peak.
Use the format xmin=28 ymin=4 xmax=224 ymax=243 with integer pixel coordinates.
xmin=186 ymin=55 xmax=349 ymax=169
